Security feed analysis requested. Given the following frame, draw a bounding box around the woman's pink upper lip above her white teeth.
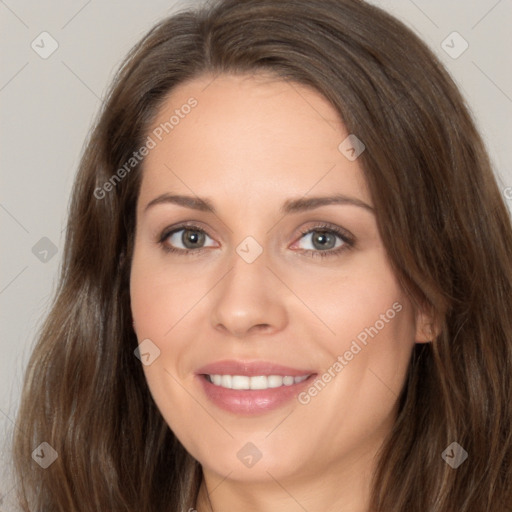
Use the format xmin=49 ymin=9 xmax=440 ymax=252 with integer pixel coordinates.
xmin=197 ymin=360 xmax=314 ymax=377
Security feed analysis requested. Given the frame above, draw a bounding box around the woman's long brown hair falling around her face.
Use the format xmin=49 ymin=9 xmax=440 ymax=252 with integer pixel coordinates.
xmin=14 ymin=0 xmax=512 ymax=512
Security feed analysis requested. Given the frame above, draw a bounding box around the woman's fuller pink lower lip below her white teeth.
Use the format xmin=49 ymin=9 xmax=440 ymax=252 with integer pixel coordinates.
xmin=197 ymin=374 xmax=316 ymax=415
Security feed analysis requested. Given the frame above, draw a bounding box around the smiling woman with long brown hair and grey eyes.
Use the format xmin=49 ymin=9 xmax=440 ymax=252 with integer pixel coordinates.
xmin=15 ymin=0 xmax=512 ymax=512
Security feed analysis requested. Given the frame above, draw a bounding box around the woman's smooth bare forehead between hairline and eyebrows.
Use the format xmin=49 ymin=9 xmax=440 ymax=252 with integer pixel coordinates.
xmin=140 ymin=74 xmax=369 ymax=209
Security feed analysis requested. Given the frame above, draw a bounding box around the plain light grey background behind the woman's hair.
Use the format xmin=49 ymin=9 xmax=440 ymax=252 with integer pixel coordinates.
xmin=0 ymin=0 xmax=512 ymax=504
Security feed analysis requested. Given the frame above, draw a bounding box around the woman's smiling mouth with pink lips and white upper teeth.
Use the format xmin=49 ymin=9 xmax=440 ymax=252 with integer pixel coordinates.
xmin=196 ymin=361 xmax=317 ymax=415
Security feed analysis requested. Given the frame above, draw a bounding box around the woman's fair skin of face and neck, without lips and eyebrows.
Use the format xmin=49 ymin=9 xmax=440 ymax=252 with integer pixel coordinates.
xmin=130 ymin=74 xmax=431 ymax=512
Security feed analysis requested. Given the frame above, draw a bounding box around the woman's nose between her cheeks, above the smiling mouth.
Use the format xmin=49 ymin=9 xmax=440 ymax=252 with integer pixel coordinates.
xmin=211 ymin=252 xmax=288 ymax=338
